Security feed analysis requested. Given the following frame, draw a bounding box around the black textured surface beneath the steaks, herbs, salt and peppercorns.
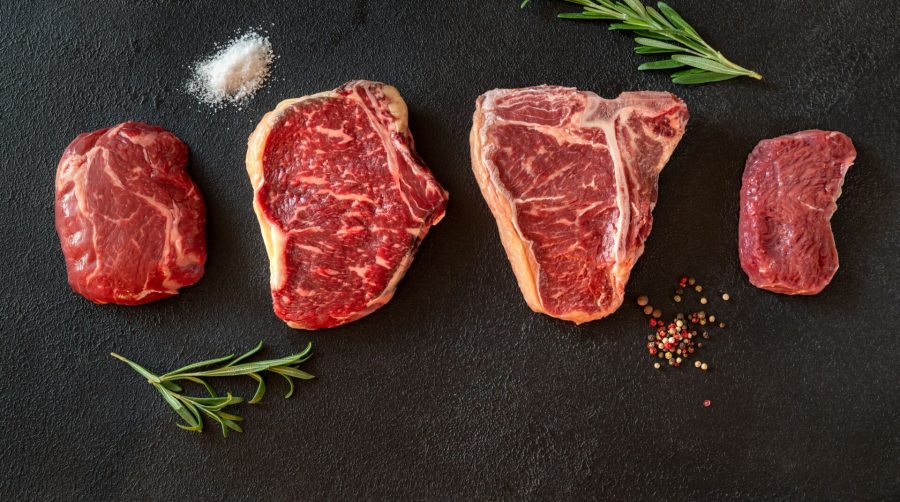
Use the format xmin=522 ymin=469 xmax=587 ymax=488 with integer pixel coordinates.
xmin=0 ymin=0 xmax=900 ymax=500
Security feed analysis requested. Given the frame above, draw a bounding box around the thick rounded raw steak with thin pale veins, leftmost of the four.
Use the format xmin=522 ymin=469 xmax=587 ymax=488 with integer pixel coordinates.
xmin=56 ymin=122 xmax=206 ymax=305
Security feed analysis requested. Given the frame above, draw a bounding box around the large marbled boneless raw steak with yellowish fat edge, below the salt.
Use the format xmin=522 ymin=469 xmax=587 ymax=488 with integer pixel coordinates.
xmin=247 ymin=81 xmax=447 ymax=329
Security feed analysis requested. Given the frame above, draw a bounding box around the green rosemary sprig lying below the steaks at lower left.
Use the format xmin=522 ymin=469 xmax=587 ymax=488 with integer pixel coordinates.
xmin=110 ymin=342 xmax=314 ymax=437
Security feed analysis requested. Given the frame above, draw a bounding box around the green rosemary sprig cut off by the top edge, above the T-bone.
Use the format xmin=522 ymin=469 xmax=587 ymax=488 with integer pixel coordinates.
xmin=520 ymin=0 xmax=762 ymax=85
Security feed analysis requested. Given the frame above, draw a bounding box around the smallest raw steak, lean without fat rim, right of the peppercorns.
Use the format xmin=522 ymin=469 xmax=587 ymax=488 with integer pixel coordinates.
xmin=739 ymin=131 xmax=856 ymax=295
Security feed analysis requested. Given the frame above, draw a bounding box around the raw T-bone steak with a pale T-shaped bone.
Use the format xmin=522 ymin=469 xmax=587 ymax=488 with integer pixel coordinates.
xmin=470 ymin=86 xmax=688 ymax=324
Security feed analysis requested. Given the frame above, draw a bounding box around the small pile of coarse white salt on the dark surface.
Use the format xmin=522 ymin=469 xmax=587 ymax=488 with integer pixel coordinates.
xmin=187 ymin=32 xmax=275 ymax=107
